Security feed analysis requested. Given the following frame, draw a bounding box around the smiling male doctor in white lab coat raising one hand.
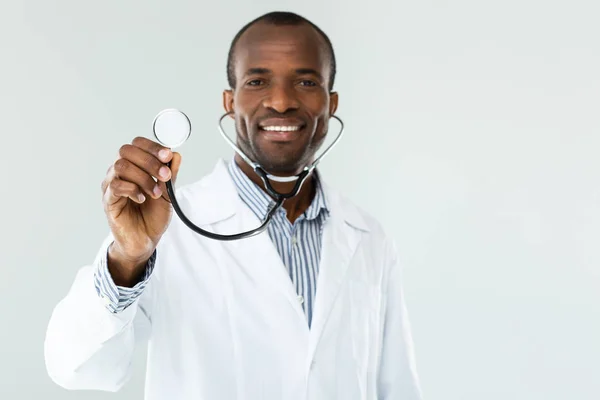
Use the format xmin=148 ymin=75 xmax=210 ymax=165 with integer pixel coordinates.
xmin=45 ymin=12 xmax=421 ymax=400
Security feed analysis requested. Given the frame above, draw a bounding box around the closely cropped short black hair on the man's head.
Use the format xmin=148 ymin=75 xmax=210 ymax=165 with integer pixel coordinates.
xmin=227 ymin=11 xmax=336 ymax=90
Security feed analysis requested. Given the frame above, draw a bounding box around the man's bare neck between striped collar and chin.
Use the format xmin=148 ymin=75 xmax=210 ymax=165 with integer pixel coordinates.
xmin=234 ymin=154 xmax=316 ymax=223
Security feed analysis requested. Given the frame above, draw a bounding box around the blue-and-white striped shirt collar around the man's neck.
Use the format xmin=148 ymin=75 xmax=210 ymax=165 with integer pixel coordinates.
xmin=229 ymin=160 xmax=329 ymax=220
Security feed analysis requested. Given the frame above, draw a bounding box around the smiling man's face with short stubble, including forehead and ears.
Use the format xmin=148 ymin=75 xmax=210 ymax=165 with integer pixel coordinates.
xmin=223 ymin=23 xmax=338 ymax=175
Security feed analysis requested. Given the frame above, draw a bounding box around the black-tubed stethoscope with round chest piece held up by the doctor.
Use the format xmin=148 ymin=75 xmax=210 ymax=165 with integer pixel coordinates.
xmin=152 ymin=108 xmax=344 ymax=241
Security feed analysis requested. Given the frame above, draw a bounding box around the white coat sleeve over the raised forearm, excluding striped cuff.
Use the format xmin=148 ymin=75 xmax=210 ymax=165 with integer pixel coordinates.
xmin=44 ymin=266 xmax=137 ymax=391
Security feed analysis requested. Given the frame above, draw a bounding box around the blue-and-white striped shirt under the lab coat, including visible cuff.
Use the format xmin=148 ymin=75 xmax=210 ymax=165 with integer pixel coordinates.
xmin=94 ymin=161 xmax=329 ymax=326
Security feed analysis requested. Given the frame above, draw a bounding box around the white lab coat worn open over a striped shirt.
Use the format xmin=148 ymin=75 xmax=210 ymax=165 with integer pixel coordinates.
xmin=45 ymin=160 xmax=421 ymax=400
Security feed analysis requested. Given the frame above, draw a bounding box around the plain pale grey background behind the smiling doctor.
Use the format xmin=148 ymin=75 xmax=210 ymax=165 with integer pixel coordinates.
xmin=0 ymin=0 xmax=600 ymax=400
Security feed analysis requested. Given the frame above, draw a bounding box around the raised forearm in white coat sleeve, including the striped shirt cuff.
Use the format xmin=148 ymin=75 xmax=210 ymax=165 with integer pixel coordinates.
xmin=44 ymin=236 xmax=153 ymax=391
